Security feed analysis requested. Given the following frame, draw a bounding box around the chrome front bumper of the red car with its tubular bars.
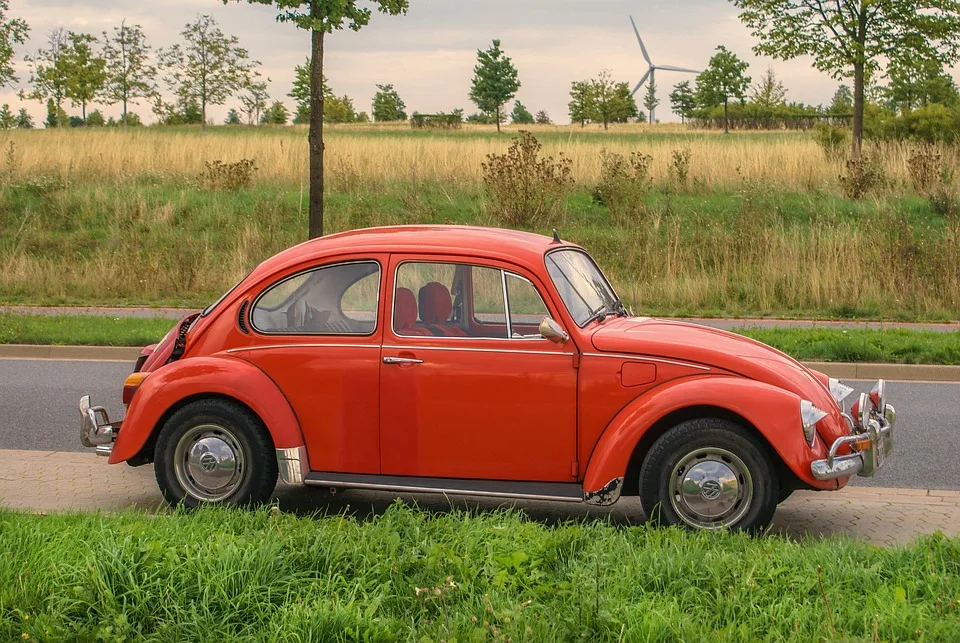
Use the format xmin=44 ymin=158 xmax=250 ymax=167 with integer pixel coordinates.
xmin=810 ymin=396 xmax=897 ymax=480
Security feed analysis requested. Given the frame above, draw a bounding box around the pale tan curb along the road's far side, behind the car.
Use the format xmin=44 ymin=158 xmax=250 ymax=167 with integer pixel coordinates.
xmin=0 ymin=344 xmax=960 ymax=382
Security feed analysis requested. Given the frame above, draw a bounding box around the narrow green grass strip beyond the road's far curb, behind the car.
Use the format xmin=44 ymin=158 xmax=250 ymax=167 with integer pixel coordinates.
xmin=0 ymin=315 xmax=960 ymax=365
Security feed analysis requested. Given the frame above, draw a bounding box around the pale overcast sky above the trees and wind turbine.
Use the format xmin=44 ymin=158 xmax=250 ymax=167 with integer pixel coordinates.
xmin=0 ymin=0 xmax=856 ymax=122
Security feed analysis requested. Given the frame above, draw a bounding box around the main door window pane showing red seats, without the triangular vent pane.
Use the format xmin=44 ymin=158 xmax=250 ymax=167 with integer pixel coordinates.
xmin=393 ymin=262 xmax=507 ymax=339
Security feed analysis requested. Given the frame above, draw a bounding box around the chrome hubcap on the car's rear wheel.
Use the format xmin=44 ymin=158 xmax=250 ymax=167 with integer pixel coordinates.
xmin=173 ymin=424 xmax=246 ymax=502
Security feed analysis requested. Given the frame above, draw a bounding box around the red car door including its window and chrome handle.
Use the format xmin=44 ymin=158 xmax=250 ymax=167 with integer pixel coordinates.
xmin=380 ymin=255 xmax=578 ymax=482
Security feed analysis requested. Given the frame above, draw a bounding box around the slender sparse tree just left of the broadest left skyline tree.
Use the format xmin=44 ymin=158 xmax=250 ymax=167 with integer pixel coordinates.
xmin=101 ymin=20 xmax=157 ymax=125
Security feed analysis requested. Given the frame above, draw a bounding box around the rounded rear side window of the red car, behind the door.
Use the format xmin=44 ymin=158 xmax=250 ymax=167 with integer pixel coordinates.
xmin=250 ymin=261 xmax=380 ymax=335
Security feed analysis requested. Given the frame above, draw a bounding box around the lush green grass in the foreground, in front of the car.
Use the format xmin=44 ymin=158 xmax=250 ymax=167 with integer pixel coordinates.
xmin=0 ymin=504 xmax=960 ymax=642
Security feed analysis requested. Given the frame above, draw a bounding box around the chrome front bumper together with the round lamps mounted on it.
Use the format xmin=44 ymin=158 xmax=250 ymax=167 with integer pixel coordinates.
xmin=810 ymin=380 xmax=897 ymax=480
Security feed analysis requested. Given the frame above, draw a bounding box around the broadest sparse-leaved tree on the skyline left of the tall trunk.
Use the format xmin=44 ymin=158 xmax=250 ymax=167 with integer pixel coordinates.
xmin=159 ymin=15 xmax=260 ymax=128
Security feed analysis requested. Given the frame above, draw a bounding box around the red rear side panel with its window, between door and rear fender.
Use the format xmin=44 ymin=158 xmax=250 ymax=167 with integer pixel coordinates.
xmin=231 ymin=255 xmax=387 ymax=474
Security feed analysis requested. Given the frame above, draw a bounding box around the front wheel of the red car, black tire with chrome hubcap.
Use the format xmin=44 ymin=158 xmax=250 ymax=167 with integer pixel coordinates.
xmin=640 ymin=418 xmax=780 ymax=531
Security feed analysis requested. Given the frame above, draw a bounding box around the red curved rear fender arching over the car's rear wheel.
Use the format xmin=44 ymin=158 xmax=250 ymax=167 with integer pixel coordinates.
xmin=110 ymin=355 xmax=304 ymax=464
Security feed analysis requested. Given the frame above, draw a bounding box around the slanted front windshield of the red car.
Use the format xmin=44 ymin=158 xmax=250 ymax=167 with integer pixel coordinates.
xmin=546 ymin=250 xmax=621 ymax=327
